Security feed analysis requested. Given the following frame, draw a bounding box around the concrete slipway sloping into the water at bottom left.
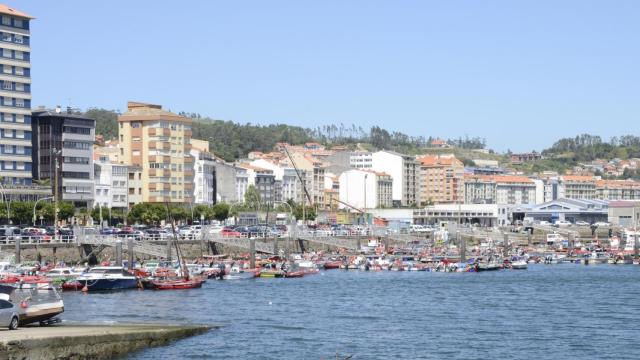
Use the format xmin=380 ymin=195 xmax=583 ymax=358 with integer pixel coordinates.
xmin=0 ymin=325 xmax=212 ymax=360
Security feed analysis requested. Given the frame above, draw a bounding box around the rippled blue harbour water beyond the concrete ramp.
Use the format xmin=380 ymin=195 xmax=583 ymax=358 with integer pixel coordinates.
xmin=64 ymin=264 xmax=640 ymax=360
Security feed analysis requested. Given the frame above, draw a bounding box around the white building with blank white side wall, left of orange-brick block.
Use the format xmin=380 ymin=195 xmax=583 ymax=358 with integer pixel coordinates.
xmin=371 ymin=150 xmax=420 ymax=206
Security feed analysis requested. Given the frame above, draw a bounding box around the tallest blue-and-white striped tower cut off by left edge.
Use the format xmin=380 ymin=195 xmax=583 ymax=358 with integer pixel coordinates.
xmin=0 ymin=4 xmax=33 ymax=186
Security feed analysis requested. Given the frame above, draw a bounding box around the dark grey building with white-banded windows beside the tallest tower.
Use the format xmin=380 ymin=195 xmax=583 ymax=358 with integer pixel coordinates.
xmin=31 ymin=107 xmax=95 ymax=208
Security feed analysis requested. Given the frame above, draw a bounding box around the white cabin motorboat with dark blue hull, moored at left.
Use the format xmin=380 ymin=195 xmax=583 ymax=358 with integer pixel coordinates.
xmin=76 ymin=266 xmax=138 ymax=292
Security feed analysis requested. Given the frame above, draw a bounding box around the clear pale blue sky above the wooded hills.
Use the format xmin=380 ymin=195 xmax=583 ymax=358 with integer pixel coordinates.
xmin=15 ymin=0 xmax=640 ymax=151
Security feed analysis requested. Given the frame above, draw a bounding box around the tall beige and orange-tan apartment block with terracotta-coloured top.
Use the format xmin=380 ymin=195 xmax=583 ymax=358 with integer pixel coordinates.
xmin=118 ymin=101 xmax=194 ymax=203
